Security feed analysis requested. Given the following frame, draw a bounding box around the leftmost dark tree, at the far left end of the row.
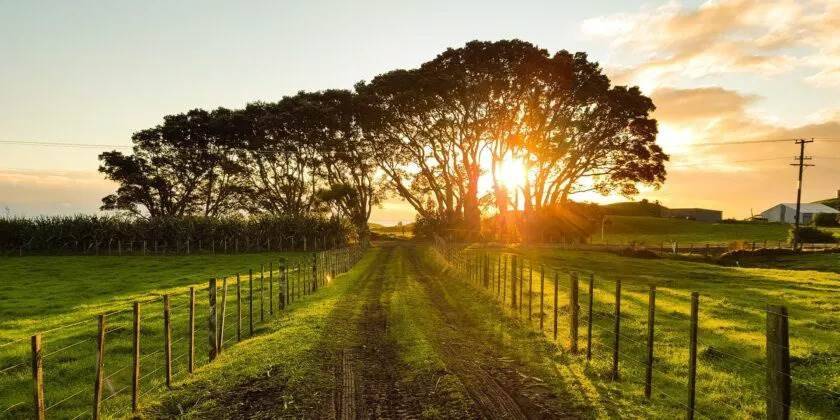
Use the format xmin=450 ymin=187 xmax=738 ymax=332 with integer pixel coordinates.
xmin=99 ymin=108 xmax=247 ymax=217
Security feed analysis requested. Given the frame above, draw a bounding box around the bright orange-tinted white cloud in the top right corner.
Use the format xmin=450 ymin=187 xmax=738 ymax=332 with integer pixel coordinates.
xmin=581 ymin=0 xmax=840 ymax=91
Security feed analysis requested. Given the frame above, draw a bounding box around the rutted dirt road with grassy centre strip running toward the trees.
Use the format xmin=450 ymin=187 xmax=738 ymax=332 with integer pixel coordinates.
xmin=170 ymin=243 xmax=580 ymax=419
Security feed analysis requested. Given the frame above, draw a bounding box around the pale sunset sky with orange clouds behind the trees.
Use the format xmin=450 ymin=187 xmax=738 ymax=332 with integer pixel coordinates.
xmin=0 ymin=0 xmax=840 ymax=224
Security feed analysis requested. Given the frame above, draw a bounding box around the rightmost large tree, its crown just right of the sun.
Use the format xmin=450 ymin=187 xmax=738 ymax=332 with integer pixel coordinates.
xmin=498 ymin=51 xmax=668 ymax=212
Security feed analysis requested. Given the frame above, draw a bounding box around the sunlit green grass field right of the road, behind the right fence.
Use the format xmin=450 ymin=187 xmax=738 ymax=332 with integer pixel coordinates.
xmin=466 ymin=244 xmax=840 ymax=418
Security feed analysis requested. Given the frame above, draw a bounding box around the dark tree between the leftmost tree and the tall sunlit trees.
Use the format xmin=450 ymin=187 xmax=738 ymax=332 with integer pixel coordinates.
xmin=226 ymin=90 xmax=382 ymax=238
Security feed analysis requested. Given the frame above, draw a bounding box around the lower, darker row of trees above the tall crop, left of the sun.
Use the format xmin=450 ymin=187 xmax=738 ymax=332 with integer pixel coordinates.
xmin=100 ymin=90 xmax=384 ymax=240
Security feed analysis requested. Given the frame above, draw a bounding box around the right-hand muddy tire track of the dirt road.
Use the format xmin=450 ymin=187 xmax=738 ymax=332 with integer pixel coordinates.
xmin=408 ymin=248 xmax=577 ymax=419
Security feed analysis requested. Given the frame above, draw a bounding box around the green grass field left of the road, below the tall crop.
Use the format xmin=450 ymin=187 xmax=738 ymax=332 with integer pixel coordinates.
xmin=0 ymin=253 xmax=324 ymax=418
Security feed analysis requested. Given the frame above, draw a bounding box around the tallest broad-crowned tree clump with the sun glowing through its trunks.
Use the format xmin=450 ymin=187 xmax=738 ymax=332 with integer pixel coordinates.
xmin=357 ymin=40 xmax=667 ymax=236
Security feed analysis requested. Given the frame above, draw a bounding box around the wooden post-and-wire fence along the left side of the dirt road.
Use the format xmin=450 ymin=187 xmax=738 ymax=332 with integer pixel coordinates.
xmin=0 ymin=247 xmax=363 ymax=419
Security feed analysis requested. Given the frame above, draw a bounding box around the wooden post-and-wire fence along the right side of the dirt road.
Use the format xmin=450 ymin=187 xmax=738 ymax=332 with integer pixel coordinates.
xmin=438 ymin=245 xmax=840 ymax=419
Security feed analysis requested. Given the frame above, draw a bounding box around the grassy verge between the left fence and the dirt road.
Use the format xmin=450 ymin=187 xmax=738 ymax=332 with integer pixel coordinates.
xmin=146 ymin=250 xmax=378 ymax=418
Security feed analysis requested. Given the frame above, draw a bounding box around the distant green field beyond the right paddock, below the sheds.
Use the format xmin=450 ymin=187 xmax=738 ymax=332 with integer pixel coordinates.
xmin=592 ymin=216 xmax=789 ymax=246
